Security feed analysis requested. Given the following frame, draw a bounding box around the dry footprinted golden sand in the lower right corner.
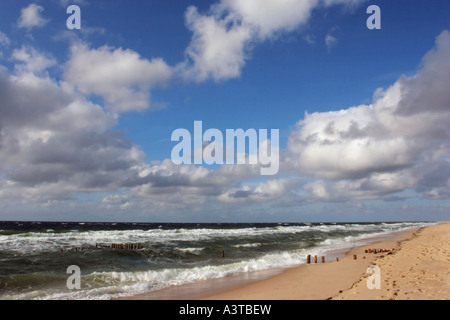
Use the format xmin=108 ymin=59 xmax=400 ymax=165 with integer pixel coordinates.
xmin=334 ymin=223 xmax=450 ymax=300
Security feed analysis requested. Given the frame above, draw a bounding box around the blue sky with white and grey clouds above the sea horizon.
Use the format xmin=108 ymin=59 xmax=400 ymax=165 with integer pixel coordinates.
xmin=0 ymin=0 xmax=450 ymax=222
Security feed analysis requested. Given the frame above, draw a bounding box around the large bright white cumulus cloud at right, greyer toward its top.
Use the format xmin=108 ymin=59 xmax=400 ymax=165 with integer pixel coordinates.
xmin=286 ymin=31 xmax=450 ymax=199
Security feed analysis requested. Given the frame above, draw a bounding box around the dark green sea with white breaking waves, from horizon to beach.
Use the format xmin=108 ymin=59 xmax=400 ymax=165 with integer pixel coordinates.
xmin=0 ymin=222 xmax=433 ymax=300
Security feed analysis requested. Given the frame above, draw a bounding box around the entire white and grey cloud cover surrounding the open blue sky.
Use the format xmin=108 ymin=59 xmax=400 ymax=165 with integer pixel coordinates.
xmin=0 ymin=0 xmax=450 ymax=220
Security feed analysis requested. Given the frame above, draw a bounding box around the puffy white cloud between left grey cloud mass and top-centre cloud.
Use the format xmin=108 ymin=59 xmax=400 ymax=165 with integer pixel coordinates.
xmin=65 ymin=43 xmax=173 ymax=112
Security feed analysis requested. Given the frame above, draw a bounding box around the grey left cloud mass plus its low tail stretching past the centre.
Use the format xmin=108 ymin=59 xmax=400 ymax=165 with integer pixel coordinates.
xmin=0 ymin=47 xmax=259 ymax=205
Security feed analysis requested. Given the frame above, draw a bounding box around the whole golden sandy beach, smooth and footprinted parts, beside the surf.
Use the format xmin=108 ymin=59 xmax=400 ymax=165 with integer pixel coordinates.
xmin=203 ymin=223 xmax=450 ymax=300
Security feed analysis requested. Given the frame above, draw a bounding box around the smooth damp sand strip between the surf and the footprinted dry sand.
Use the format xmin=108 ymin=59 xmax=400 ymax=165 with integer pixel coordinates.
xmin=113 ymin=222 xmax=450 ymax=300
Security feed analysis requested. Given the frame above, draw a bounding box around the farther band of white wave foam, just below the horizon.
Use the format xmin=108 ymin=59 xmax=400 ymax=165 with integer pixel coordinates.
xmin=0 ymin=223 xmax=436 ymax=254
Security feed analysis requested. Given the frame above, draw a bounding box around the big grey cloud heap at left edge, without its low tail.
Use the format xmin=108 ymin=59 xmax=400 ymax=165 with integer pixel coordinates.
xmin=0 ymin=49 xmax=145 ymax=201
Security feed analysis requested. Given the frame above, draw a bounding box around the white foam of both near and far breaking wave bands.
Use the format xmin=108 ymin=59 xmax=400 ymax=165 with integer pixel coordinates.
xmin=0 ymin=223 xmax=436 ymax=299
